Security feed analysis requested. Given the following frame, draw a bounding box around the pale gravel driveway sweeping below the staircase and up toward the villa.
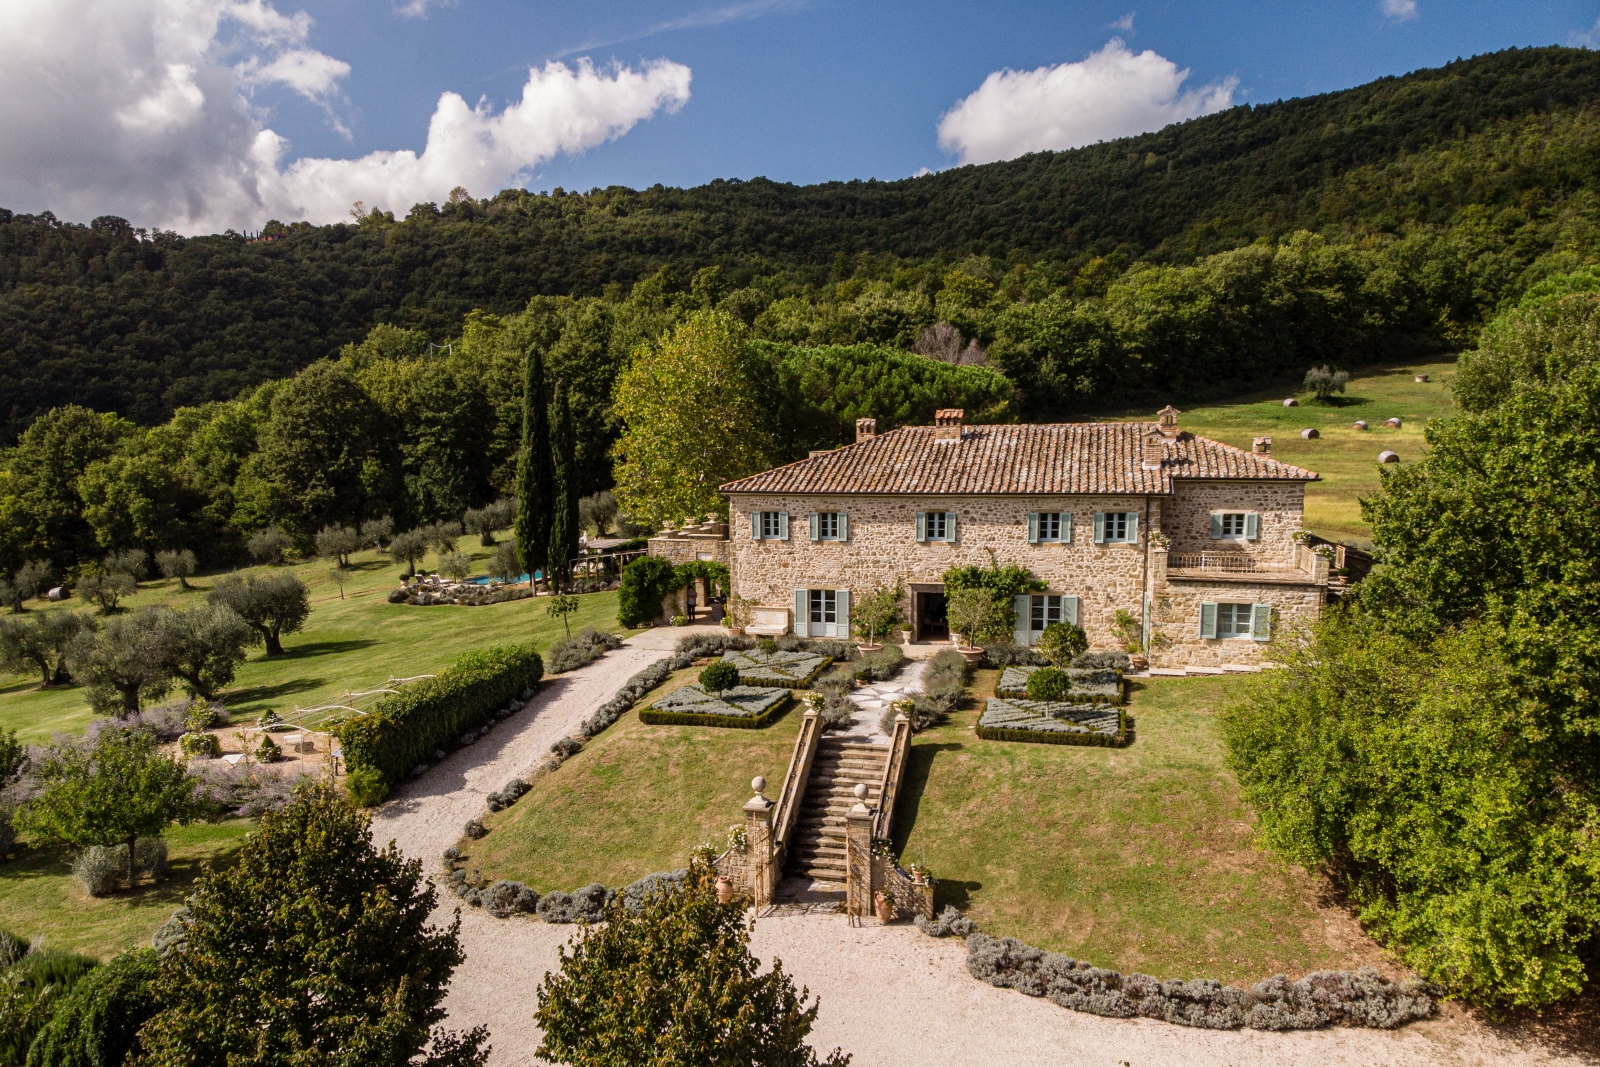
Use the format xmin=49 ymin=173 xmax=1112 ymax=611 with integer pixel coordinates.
xmin=373 ymin=646 xmax=1592 ymax=1067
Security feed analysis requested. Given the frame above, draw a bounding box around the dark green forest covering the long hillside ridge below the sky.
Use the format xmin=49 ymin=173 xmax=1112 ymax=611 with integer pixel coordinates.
xmin=9 ymin=48 xmax=1600 ymax=442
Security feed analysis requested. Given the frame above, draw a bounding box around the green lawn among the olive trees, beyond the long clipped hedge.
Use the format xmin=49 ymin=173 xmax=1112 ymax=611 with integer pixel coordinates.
xmin=0 ymin=536 xmax=616 ymax=741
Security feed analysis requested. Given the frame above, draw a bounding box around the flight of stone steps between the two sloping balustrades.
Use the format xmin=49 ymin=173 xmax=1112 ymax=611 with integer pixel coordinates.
xmin=784 ymin=734 xmax=890 ymax=885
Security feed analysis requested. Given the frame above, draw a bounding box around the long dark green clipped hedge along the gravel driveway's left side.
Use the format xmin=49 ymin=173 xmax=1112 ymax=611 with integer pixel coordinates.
xmin=338 ymin=645 xmax=544 ymax=789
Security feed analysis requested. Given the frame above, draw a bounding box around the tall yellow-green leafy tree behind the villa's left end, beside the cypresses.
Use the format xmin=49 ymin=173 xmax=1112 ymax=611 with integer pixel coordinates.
xmin=616 ymin=312 xmax=779 ymax=523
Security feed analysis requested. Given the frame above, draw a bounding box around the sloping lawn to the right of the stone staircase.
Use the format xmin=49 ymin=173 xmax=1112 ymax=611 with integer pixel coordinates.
xmin=894 ymin=670 xmax=1373 ymax=982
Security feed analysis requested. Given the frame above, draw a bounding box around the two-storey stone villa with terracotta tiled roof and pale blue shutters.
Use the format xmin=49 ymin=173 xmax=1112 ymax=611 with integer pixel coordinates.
xmin=717 ymin=406 xmax=1328 ymax=667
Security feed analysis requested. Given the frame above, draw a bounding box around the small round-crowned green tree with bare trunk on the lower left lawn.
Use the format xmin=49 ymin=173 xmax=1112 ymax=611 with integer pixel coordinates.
xmin=16 ymin=729 xmax=197 ymax=888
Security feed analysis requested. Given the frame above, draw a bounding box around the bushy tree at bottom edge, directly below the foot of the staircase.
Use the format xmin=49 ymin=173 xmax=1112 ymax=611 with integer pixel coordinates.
xmin=534 ymin=859 xmax=850 ymax=1067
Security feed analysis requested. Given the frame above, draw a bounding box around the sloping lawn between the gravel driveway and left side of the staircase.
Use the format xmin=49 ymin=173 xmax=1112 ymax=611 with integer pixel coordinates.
xmin=459 ymin=667 xmax=802 ymax=893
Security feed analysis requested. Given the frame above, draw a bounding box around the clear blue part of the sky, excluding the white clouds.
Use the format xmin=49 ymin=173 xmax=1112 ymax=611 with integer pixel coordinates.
xmin=272 ymin=0 xmax=1600 ymax=195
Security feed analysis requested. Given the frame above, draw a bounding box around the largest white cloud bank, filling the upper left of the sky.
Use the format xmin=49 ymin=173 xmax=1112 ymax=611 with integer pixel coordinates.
xmin=0 ymin=0 xmax=691 ymax=234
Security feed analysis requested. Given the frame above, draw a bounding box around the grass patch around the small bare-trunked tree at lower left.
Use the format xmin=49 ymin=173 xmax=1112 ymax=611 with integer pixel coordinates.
xmin=0 ymin=819 xmax=254 ymax=960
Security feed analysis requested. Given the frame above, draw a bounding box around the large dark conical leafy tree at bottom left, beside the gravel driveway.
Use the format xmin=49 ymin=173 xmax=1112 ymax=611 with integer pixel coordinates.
xmin=136 ymin=785 xmax=488 ymax=1067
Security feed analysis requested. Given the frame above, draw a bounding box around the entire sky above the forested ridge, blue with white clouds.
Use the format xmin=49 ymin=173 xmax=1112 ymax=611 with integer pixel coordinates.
xmin=0 ymin=0 xmax=1600 ymax=234
